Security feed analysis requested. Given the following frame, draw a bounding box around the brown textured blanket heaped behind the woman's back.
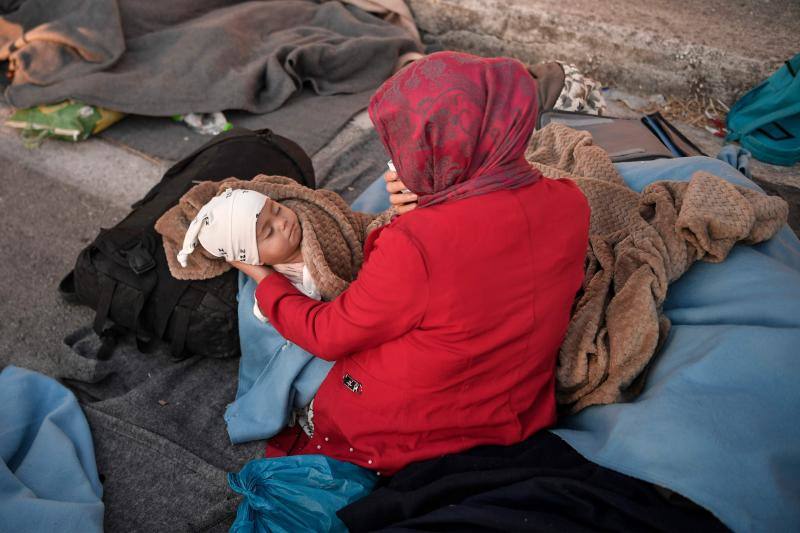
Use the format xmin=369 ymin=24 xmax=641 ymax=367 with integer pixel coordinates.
xmin=526 ymin=124 xmax=788 ymax=413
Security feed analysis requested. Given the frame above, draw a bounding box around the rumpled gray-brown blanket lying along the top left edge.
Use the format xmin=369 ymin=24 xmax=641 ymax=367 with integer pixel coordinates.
xmin=0 ymin=0 xmax=419 ymax=116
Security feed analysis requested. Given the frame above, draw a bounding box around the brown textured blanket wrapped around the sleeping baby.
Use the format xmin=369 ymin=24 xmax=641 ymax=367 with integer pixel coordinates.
xmin=155 ymin=174 xmax=392 ymax=300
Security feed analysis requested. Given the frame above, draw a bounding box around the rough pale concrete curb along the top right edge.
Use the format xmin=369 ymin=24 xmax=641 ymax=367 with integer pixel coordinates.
xmin=409 ymin=0 xmax=800 ymax=102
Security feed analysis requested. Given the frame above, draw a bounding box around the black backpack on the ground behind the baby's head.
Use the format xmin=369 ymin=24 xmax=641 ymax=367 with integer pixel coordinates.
xmin=59 ymin=128 xmax=315 ymax=358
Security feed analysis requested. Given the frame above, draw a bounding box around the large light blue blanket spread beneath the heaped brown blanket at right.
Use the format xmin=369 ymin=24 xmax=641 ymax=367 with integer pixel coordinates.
xmin=555 ymin=157 xmax=800 ymax=531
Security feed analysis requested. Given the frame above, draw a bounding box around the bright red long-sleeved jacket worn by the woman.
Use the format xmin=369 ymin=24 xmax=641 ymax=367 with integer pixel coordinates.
xmin=256 ymin=179 xmax=589 ymax=474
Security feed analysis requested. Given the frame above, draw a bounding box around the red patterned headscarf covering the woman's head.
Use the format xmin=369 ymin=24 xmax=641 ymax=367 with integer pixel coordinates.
xmin=369 ymin=52 xmax=541 ymax=206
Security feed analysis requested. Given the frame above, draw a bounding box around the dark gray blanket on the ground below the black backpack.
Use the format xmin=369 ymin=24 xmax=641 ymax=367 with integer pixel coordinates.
xmin=56 ymin=327 xmax=264 ymax=531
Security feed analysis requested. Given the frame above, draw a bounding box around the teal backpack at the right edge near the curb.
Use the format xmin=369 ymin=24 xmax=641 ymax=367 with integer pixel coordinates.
xmin=726 ymin=54 xmax=800 ymax=166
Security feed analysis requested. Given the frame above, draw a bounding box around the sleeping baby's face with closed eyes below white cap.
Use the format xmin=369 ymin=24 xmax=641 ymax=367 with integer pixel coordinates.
xmin=256 ymin=198 xmax=303 ymax=265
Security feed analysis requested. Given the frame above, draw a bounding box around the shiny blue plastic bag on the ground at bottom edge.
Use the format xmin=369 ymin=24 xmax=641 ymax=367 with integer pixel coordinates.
xmin=228 ymin=455 xmax=377 ymax=533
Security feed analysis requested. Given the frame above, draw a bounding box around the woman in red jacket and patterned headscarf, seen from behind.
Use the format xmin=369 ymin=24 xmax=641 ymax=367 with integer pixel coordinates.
xmin=234 ymin=52 xmax=589 ymax=474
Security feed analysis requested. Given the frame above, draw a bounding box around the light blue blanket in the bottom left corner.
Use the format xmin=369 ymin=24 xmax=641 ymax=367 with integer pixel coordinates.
xmin=0 ymin=366 xmax=103 ymax=533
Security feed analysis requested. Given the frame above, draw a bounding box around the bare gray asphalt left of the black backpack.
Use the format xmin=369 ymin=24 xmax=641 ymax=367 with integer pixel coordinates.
xmin=0 ymin=157 xmax=126 ymax=370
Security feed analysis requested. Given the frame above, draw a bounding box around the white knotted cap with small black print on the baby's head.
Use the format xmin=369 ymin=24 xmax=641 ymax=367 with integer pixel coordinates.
xmin=178 ymin=189 xmax=268 ymax=267
